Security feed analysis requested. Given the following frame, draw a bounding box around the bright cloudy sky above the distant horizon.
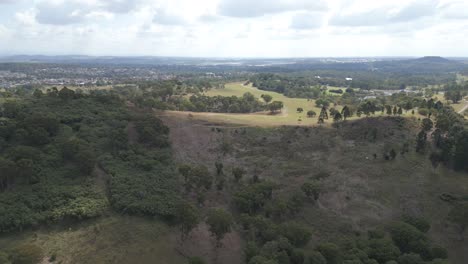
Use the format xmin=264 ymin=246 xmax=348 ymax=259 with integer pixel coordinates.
xmin=0 ymin=0 xmax=468 ymax=57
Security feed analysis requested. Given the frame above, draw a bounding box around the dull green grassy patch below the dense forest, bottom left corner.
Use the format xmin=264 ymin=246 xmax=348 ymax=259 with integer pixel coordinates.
xmin=0 ymin=215 xmax=187 ymax=264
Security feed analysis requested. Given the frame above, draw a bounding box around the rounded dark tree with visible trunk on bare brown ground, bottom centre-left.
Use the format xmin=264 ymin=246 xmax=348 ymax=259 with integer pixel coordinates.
xmin=206 ymin=209 xmax=233 ymax=247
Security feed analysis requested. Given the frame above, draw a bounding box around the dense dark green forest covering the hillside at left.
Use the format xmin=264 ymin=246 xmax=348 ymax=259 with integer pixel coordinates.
xmin=0 ymin=88 xmax=186 ymax=232
